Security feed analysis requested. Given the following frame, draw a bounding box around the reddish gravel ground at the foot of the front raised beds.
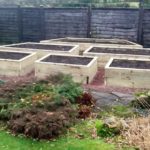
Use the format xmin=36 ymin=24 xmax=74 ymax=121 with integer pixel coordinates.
xmin=0 ymin=68 xmax=146 ymax=97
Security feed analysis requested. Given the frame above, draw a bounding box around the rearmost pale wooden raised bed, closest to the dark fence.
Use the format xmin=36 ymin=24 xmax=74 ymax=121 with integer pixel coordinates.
xmin=41 ymin=37 xmax=142 ymax=54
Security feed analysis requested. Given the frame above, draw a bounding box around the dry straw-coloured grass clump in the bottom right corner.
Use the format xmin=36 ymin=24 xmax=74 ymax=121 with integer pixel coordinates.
xmin=122 ymin=117 xmax=150 ymax=150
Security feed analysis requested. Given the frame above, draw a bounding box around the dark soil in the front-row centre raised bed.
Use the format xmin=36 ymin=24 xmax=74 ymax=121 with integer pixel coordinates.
xmin=42 ymin=55 xmax=92 ymax=65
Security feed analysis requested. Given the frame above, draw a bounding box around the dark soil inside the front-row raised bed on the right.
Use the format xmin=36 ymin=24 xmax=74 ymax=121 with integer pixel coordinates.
xmin=110 ymin=59 xmax=150 ymax=69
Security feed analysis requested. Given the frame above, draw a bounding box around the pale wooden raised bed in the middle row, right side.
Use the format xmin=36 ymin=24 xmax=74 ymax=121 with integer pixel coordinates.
xmin=84 ymin=46 xmax=150 ymax=67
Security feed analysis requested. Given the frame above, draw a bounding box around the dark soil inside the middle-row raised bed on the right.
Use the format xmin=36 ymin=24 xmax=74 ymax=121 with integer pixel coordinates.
xmin=89 ymin=47 xmax=150 ymax=55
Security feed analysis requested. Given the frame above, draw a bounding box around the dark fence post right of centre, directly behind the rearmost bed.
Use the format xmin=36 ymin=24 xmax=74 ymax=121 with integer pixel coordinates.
xmin=87 ymin=5 xmax=92 ymax=38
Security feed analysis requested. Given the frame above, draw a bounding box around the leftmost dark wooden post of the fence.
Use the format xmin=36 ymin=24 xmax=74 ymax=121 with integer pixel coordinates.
xmin=17 ymin=6 xmax=23 ymax=42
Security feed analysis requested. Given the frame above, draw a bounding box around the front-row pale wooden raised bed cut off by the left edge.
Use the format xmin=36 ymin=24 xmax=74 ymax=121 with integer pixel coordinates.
xmin=0 ymin=50 xmax=37 ymax=76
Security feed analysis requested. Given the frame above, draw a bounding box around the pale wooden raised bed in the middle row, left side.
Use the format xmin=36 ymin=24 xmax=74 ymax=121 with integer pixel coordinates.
xmin=2 ymin=42 xmax=79 ymax=58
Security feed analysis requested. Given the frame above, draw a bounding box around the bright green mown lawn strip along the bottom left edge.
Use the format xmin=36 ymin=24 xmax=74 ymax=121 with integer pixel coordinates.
xmin=0 ymin=131 xmax=115 ymax=150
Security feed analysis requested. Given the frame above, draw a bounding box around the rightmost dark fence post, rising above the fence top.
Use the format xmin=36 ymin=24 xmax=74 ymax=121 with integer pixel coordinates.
xmin=137 ymin=0 xmax=144 ymax=44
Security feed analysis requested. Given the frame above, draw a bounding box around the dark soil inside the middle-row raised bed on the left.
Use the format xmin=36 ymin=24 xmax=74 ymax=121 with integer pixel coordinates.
xmin=9 ymin=43 xmax=73 ymax=51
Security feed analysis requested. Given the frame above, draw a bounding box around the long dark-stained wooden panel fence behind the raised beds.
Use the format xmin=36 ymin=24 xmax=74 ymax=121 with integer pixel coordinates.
xmin=0 ymin=6 xmax=150 ymax=47
